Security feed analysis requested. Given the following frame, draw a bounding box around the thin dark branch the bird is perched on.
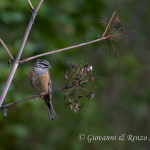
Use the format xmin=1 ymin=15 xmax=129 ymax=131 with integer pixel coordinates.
xmin=0 ymin=86 xmax=73 ymax=110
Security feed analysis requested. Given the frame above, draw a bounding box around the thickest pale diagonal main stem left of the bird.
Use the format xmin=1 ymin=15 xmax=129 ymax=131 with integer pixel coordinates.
xmin=0 ymin=0 xmax=43 ymax=106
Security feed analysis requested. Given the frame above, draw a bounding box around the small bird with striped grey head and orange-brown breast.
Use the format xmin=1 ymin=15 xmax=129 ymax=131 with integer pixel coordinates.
xmin=28 ymin=59 xmax=56 ymax=120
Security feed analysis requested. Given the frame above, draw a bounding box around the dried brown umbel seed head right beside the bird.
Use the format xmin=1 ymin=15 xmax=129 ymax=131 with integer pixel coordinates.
xmin=64 ymin=63 xmax=96 ymax=112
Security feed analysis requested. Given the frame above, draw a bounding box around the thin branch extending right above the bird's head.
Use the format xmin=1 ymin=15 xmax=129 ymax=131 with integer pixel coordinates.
xmin=20 ymin=35 xmax=110 ymax=64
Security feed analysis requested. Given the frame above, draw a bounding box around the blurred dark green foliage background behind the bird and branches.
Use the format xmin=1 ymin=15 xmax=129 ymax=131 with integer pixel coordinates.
xmin=0 ymin=0 xmax=150 ymax=150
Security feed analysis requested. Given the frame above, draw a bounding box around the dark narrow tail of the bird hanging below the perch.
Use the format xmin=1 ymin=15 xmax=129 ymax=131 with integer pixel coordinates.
xmin=46 ymin=101 xmax=56 ymax=120
